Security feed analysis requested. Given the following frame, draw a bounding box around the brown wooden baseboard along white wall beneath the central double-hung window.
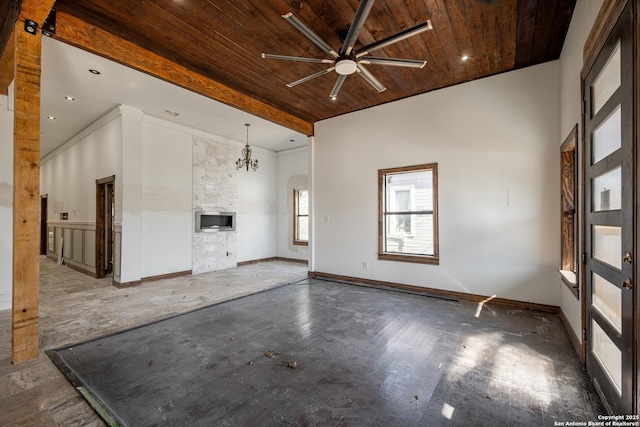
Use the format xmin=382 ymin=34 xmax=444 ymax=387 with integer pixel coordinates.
xmin=308 ymin=271 xmax=560 ymax=314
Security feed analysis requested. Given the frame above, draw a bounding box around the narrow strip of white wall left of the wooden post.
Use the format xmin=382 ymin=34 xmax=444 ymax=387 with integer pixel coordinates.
xmin=0 ymin=95 xmax=13 ymax=310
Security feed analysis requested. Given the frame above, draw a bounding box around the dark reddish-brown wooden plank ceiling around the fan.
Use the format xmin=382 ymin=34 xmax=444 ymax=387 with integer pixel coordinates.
xmin=7 ymin=0 xmax=576 ymax=127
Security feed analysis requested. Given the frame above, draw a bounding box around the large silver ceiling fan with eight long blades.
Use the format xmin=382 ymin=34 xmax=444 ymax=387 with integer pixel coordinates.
xmin=262 ymin=0 xmax=433 ymax=100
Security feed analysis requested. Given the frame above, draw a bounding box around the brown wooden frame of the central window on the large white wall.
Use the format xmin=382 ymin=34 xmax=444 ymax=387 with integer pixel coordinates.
xmin=378 ymin=163 xmax=440 ymax=265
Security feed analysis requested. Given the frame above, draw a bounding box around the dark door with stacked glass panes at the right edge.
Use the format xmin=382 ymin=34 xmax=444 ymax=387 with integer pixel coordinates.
xmin=584 ymin=2 xmax=635 ymax=414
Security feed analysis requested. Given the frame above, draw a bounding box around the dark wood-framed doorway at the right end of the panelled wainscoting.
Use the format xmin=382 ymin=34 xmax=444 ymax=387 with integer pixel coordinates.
xmin=96 ymin=175 xmax=116 ymax=278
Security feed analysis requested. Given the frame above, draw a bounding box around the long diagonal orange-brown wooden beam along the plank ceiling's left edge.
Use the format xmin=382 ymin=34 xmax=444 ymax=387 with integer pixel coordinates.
xmin=55 ymin=11 xmax=313 ymax=135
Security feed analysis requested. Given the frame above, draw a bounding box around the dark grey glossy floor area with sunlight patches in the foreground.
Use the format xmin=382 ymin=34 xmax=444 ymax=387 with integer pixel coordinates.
xmin=51 ymin=279 xmax=601 ymax=427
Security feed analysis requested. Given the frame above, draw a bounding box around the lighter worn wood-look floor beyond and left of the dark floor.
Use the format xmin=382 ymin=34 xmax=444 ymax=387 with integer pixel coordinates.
xmin=0 ymin=257 xmax=307 ymax=427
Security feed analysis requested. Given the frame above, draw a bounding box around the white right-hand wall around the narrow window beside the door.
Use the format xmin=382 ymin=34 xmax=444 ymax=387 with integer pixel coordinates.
xmin=558 ymin=0 xmax=603 ymax=340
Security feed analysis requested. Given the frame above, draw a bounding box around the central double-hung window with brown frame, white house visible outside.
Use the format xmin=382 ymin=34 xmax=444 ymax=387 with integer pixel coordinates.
xmin=378 ymin=163 xmax=439 ymax=264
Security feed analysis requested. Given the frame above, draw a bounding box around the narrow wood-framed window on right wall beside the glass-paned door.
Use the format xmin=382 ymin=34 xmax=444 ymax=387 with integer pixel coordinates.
xmin=560 ymin=125 xmax=580 ymax=298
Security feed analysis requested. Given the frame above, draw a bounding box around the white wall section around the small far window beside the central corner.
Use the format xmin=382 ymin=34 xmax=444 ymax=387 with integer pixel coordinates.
xmin=276 ymin=147 xmax=309 ymax=260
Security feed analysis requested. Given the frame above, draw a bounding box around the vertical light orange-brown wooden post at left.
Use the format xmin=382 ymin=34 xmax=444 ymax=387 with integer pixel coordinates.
xmin=12 ymin=21 xmax=42 ymax=363
